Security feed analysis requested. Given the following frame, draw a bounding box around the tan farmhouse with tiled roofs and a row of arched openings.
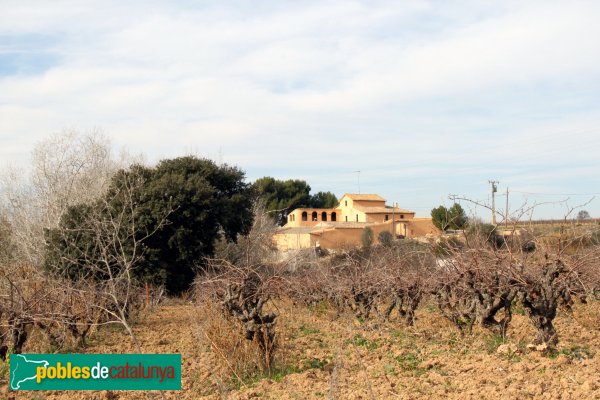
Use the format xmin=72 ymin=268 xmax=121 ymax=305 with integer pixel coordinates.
xmin=273 ymin=194 xmax=439 ymax=251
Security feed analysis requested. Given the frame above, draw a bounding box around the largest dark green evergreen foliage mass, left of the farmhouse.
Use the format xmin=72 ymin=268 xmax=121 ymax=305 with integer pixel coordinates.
xmin=46 ymin=156 xmax=253 ymax=292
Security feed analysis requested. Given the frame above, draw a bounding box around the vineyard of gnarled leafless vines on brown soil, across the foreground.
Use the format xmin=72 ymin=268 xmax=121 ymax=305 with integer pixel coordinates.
xmin=3 ymin=218 xmax=600 ymax=399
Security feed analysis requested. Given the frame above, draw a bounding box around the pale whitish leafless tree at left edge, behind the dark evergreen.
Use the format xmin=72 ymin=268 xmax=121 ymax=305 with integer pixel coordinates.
xmin=0 ymin=132 xmax=134 ymax=265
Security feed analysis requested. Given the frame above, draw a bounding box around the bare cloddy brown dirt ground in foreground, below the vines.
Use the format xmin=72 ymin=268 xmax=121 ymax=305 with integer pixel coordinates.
xmin=0 ymin=302 xmax=600 ymax=400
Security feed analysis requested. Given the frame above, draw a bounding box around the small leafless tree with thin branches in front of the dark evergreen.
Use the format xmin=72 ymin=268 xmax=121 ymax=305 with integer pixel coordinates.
xmin=46 ymin=170 xmax=171 ymax=350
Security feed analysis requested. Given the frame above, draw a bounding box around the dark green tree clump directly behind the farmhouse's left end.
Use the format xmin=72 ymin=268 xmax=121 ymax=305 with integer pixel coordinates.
xmin=253 ymin=176 xmax=338 ymax=225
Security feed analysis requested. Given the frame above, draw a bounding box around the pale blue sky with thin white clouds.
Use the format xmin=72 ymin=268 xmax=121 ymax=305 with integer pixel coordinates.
xmin=0 ymin=0 xmax=600 ymax=219
